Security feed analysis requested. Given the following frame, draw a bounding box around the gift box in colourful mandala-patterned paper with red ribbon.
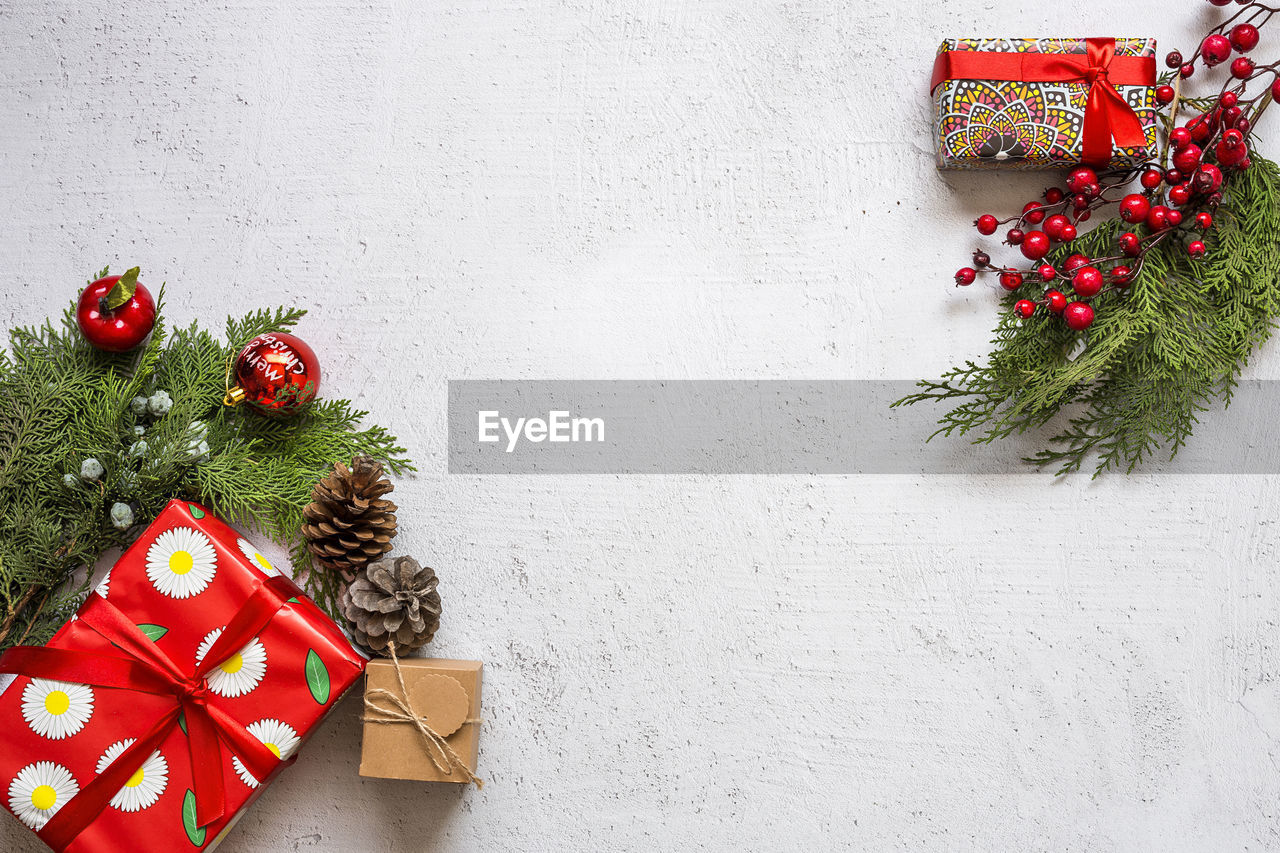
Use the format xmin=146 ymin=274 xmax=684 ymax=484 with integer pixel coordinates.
xmin=929 ymin=38 xmax=1156 ymax=169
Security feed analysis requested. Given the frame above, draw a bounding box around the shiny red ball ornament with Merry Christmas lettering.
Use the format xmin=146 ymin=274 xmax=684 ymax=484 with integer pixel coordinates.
xmin=223 ymin=330 xmax=322 ymax=416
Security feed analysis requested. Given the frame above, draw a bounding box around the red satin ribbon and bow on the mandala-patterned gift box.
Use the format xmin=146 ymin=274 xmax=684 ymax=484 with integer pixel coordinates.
xmin=929 ymin=38 xmax=1156 ymax=165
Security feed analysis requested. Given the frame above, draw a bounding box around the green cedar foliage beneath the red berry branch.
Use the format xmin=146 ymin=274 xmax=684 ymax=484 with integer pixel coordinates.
xmin=893 ymin=156 xmax=1280 ymax=476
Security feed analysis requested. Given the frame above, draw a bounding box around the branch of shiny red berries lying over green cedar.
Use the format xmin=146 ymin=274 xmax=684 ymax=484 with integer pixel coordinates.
xmin=955 ymin=0 xmax=1280 ymax=330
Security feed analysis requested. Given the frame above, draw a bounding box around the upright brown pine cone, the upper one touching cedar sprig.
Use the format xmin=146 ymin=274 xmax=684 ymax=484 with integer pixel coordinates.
xmin=302 ymin=456 xmax=396 ymax=575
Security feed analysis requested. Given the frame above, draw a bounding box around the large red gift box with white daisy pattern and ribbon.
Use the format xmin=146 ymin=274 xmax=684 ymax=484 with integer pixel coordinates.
xmin=0 ymin=501 xmax=365 ymax=853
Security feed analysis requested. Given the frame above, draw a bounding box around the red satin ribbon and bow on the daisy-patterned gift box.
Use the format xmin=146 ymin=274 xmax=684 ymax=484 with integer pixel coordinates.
xmin=0 ymin=575 xmax=298 ymax=850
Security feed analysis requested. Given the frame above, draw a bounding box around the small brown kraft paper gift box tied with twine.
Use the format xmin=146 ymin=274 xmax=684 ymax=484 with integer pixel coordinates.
xmin=360 ymin=657 xmax=483 ymax=785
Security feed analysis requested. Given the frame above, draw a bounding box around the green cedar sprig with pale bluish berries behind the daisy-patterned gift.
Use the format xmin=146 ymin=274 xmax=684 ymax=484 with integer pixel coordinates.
xmin=0 ymin=284 xmax=413 ymax=649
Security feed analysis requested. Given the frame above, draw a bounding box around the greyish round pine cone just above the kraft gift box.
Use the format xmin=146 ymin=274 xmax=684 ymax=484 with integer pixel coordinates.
xmin=342 ymin=557 xmax=440 ymax=654
